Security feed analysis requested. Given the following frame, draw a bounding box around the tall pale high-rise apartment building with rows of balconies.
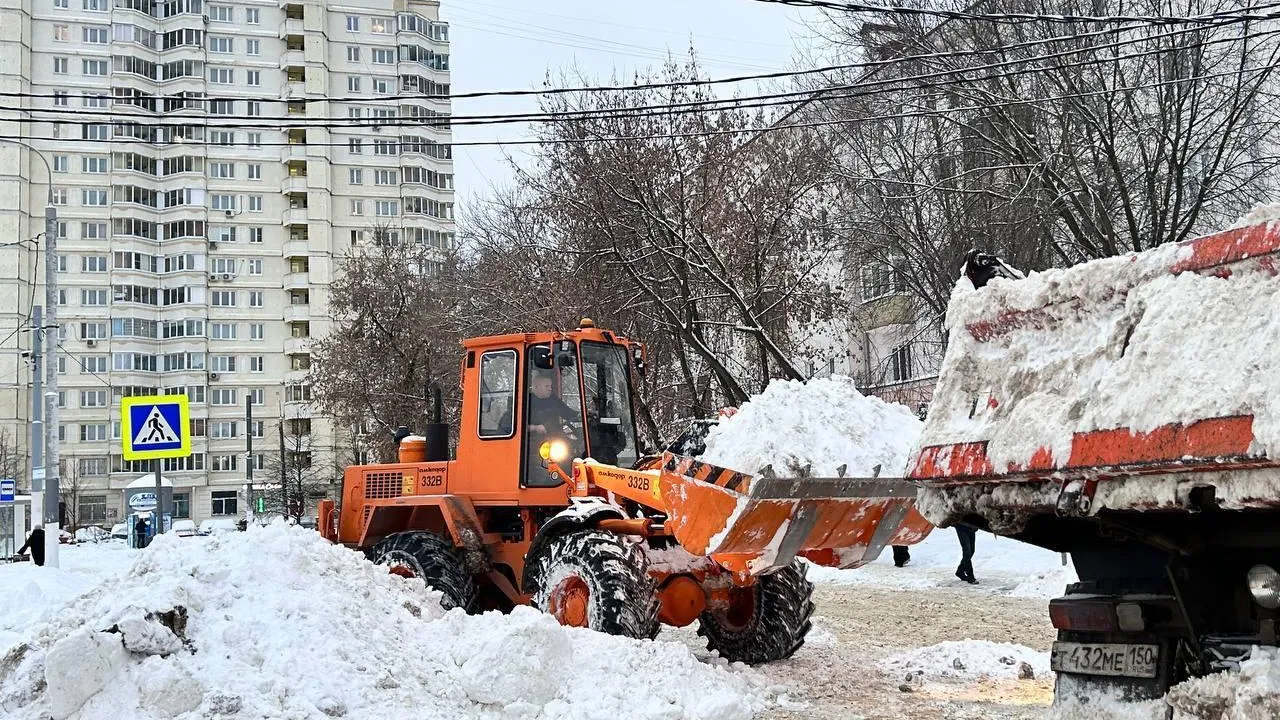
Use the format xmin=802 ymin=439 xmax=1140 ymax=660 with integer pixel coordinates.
xmin=0 ymin=0 xmax=453 ymax=523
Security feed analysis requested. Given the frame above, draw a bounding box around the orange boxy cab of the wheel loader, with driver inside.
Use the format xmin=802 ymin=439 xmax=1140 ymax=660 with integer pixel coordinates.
xmin=457 ymin=322 xmax=643 ymax=491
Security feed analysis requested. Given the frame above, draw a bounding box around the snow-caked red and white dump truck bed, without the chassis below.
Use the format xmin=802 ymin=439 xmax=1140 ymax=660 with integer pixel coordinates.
xmin=909 ymin=223 xmax=1280 ymax=534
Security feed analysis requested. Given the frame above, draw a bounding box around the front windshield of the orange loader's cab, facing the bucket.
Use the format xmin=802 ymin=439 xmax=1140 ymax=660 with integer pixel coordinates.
xmin=582 ymin=342 xmax=639 ymax=468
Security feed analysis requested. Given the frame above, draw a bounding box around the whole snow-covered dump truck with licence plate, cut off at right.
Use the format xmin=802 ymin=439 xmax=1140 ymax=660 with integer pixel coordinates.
xmin=909 ymin=223 xmax=1280 ymax=698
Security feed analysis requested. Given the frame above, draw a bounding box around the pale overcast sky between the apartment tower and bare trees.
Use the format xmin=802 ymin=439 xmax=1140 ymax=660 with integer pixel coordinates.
xmin=440 ymin=0 xmax=815 ymax=210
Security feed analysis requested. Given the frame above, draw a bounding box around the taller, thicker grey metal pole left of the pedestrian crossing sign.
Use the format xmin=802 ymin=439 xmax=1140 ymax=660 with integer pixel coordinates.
xmin=43 ymin=203 xmax=60 ymax=568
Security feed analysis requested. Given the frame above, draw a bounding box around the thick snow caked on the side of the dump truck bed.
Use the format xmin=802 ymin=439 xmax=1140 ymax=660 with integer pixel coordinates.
xmin=923 ymin=228 xmax=1280 ymax=470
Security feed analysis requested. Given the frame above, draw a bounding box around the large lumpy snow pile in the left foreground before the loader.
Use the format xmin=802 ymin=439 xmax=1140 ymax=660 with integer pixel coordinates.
xmin=0 ymin=524 xmax=765 ymax=720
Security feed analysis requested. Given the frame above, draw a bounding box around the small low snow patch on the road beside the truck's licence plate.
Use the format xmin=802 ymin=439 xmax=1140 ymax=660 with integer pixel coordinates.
xmin=879 ymin=641 xmax=1050 ymax=680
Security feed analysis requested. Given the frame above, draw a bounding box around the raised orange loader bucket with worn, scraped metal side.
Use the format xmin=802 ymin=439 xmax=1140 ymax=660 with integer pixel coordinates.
xmin=660 ymin=455 xmax=933 ymax=575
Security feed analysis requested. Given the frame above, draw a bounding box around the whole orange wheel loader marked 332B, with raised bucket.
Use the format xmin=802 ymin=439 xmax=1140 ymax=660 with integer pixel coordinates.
xmin=319 ymin=320 xmax=932 ymax=664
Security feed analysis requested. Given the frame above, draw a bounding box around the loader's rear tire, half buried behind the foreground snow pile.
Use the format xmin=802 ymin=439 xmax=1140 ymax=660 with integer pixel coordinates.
xmin=369 ymin=532 xmax=479 ymax=612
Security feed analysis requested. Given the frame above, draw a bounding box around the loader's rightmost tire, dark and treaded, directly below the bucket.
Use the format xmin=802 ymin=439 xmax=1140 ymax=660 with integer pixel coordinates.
xmin=698 ymin=561 xmax=813 ymax=665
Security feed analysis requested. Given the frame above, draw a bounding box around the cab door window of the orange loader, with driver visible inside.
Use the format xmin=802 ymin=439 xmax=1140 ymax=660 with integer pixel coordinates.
xmin=525 ymin=341 xmax=586 ymax=487
